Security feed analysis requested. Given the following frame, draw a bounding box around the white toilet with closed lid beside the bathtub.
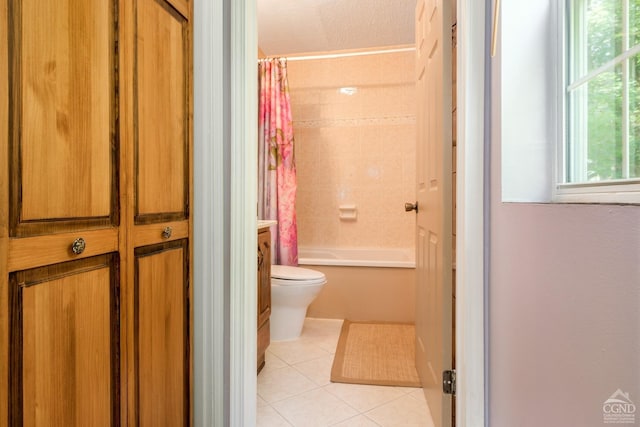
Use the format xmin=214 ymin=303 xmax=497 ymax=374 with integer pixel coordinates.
xmin=270 ymin=265 xmax=327 ymax=341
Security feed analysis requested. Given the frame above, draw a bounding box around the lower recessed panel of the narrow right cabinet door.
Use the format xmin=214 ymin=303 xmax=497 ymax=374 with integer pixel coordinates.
xmin=134 ymin=239 xmax=190 ymax=427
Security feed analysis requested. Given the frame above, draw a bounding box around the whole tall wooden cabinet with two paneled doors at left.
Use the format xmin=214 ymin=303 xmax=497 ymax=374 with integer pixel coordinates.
xmin=0 ymin=0 xmax=193 ymax=427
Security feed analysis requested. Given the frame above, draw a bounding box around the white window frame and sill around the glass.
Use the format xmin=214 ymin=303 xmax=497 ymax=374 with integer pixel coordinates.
xmin=550 ymin=0 xmax=640 ymax=204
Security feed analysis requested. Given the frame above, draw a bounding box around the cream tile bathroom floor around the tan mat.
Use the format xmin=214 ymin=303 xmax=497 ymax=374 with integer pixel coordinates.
xmin=257 ymin=318 xmax=433 ymax=427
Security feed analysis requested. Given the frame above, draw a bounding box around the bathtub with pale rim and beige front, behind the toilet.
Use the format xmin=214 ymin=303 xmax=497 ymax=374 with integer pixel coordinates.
xmin=298 ymin=247 xmax=415 ymax=322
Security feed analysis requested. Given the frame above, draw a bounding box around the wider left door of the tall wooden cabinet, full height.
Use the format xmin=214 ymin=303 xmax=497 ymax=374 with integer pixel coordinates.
xmin=0 ymin=0 xmax=122 ymax=426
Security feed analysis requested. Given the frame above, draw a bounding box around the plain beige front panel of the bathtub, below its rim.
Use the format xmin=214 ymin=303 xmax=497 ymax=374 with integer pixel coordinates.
xmin=304 ymin=265 xmax=415 ymax=322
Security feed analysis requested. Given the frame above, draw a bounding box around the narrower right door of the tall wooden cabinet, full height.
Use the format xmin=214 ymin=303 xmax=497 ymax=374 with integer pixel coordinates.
xmin=126 ymin=0 xmax=192 ymax=427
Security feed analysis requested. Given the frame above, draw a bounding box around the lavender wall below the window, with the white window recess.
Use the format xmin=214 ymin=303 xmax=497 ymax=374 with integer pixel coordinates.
xmin=488 ymin=0 xmax=640 ymax=427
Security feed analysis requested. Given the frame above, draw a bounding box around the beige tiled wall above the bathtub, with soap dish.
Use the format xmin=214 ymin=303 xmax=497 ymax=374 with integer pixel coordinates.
xmin=288 ymin=51 xmax=415 ymax=256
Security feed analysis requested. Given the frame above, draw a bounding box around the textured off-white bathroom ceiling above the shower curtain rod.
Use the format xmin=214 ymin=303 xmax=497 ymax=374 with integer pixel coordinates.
xmin=257 ymin=0 xmax=416 ymax=56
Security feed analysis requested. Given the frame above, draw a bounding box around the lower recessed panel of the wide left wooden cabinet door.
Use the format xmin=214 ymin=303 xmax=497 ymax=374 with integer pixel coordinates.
xmin=9 ymin=254 xmax=120 ymax=426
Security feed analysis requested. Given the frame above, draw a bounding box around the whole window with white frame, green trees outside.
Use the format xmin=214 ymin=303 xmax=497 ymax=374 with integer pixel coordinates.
xmin=556 ymin=0 xmax=640 ymax=203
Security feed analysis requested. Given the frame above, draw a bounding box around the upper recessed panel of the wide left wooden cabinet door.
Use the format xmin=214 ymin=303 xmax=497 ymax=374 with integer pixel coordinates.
xmin=8 ymin=0 xmax=118 ymax=237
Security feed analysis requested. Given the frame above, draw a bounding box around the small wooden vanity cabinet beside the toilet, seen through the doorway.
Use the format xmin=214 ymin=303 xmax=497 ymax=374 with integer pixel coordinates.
xmin=258 ymin=228 xmax=271 ymax=372
